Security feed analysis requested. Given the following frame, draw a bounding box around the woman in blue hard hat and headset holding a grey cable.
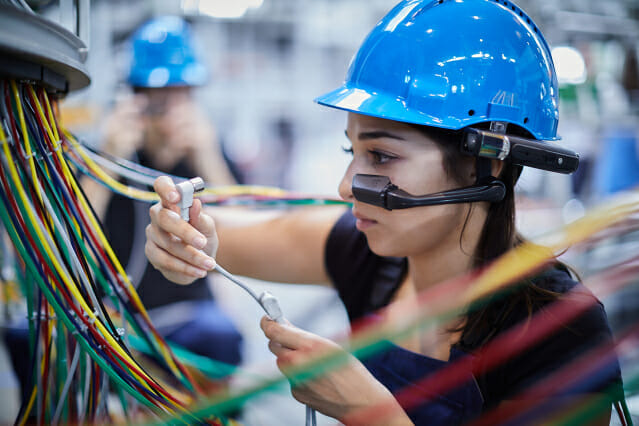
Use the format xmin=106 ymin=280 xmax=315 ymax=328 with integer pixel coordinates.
xmin=146 ymin=0 xmax=620 ymax=424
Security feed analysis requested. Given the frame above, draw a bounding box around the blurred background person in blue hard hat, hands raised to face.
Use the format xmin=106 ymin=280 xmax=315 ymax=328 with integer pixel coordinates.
xmin=83 ymin=16 xmax=242 ymax=365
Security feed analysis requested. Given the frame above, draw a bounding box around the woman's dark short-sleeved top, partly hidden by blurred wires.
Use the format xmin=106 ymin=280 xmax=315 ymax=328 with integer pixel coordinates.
xmin=325 ymin=211 xmax=621 ymax=424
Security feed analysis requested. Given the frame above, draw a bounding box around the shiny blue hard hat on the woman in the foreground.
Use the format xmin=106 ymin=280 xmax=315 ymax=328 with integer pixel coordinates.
xmin=316 ymin=0 xmax=559 ymax=140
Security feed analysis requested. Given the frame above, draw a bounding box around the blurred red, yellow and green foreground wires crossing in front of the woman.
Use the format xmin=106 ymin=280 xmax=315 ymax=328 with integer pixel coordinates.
xmin=179 ymin=191 xmax=639 ymax=425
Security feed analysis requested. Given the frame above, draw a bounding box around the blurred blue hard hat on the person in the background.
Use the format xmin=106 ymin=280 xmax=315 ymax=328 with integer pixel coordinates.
xmin=128 ymin=16 xmax=208 ymax=87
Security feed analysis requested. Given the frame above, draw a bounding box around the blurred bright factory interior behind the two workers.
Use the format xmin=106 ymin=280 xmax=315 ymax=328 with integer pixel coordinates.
xmin=0 ymin=0 xmax=639 ymax=424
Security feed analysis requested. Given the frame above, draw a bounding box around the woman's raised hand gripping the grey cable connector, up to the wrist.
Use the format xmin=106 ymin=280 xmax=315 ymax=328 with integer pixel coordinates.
xmin=145 ymin=176 xmax=218 ymax=284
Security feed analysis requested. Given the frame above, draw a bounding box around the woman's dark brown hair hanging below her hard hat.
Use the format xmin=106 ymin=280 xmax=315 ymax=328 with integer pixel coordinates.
xmin=416 ymin=125 xmax=557 ymax=350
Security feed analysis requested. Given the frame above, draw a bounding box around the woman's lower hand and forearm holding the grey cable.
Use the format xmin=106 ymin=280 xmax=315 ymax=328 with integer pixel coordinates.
xmin=260 ymin=317 xmax=412 ymax=425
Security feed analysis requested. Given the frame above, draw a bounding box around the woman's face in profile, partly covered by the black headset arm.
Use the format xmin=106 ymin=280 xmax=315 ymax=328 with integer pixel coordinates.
xmin=339 ymin=113 xmax=474 ymax=257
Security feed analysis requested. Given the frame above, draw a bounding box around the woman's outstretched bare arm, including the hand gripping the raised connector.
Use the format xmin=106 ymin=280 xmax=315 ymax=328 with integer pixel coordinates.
xmin=145 ymin=176 xmax=343 ymax=284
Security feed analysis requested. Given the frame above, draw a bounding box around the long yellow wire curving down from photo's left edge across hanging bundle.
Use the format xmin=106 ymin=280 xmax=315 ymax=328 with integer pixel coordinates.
xmin=0 ymin=104 xmax=172 ymax=412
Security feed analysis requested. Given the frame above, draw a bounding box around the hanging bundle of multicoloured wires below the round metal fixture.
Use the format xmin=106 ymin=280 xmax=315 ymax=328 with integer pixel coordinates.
xmin=0 ymin=80 xmax=229 ymax=424
